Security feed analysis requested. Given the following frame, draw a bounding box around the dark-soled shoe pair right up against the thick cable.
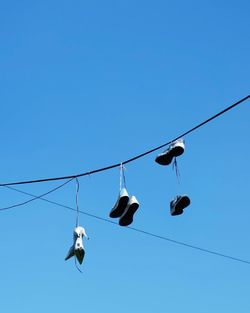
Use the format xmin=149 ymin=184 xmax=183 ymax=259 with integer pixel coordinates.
xmin=155 ymin=138 xmax=185 ymax=165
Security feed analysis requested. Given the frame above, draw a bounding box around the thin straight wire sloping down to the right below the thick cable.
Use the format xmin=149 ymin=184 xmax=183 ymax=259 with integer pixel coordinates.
xmin=5 ymin=186 xmax=250 ymax=265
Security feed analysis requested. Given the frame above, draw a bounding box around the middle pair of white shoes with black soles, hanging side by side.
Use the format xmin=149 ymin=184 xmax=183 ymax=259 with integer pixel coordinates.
xmin=109 ymin=188 xmax=139 ymax=226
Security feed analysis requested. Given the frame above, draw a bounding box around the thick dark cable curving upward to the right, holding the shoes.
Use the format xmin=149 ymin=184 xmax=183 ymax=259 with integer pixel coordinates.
xmin=0 ymin=95 xmax=250 ymax=187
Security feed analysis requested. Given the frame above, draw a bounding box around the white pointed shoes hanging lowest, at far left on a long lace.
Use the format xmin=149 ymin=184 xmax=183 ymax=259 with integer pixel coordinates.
xmin=65 ymin=226 xmax=89 ymax=264
